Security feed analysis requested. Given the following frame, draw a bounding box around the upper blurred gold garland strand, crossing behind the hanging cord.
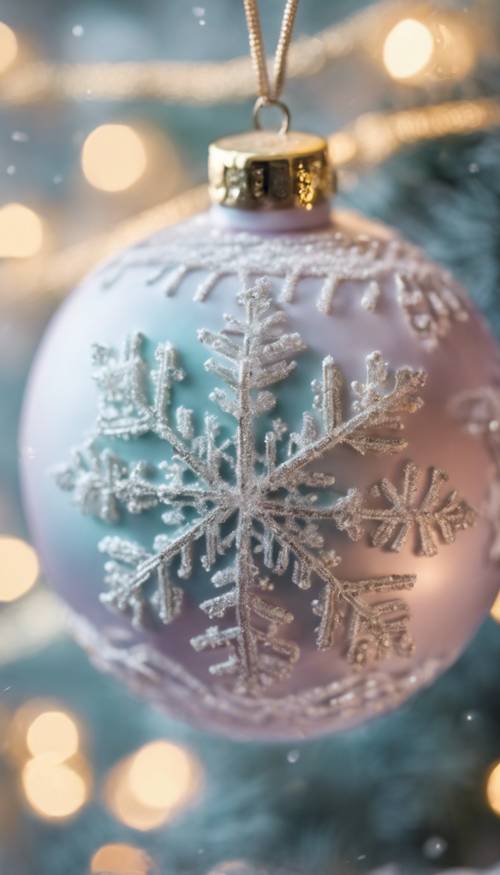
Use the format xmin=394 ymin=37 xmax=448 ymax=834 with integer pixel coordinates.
xmin=0 ymin=0 xmax=431 ymax=105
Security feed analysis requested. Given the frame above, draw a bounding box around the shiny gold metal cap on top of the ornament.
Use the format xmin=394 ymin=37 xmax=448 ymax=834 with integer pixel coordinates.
xmin=208 ymin=130 xmax=333 ymax=210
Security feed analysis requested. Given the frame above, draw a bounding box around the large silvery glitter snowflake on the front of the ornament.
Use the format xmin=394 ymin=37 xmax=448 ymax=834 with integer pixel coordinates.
xmin=57 ymin=280 xmax=473 ymax=695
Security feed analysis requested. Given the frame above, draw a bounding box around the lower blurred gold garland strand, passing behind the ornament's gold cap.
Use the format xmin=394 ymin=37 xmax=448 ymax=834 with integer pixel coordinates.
xmin=0 ymin=98 xmax=500 ymax=306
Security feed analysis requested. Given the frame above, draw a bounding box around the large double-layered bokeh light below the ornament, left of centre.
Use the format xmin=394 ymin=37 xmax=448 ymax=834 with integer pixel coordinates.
xmin=104 ymin=741 xmax=201 ymax=831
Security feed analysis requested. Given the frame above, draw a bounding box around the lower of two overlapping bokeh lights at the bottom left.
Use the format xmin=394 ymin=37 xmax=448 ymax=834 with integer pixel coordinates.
xmin=22 ymin=756 xmax=88 ymax=820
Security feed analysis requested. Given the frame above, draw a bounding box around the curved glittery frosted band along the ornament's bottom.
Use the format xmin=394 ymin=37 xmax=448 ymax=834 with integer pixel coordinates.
xmin=67 ymin=610 xmax=450 ymax=738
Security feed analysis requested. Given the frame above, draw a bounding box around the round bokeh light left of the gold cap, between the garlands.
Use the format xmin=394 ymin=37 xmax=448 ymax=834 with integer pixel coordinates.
xmin=82 ymin=125 xmax=147 ymax=192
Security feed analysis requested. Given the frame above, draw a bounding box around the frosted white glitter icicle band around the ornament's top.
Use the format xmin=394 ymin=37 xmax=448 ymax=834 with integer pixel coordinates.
xmin=98 ymin=219 xmax=468 ymax=348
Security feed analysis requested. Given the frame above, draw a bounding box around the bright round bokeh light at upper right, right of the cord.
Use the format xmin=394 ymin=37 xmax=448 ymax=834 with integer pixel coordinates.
xmin=383 ymin=18 xmax=434 ymax=79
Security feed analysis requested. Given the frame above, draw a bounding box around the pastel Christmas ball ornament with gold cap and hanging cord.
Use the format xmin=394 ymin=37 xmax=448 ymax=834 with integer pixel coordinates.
xmin=22 ymin=0 xmax=498 ymax=738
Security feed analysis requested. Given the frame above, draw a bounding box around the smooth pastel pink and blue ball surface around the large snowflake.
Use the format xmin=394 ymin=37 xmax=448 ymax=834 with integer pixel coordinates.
xmin=21 ymin=210 xmax=499 ymax=738
